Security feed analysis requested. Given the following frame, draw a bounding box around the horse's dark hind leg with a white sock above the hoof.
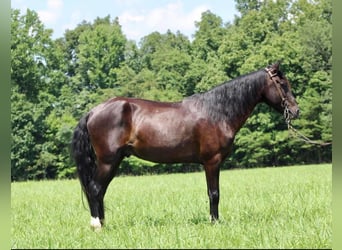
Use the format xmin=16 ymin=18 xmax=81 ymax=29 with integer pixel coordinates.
xmin=87 ymin=155 xmax=123 ymax=229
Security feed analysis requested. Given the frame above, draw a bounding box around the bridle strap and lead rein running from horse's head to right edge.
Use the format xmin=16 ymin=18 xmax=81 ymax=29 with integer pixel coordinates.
xmin=265 ymin=68 xmax=332 ymax=147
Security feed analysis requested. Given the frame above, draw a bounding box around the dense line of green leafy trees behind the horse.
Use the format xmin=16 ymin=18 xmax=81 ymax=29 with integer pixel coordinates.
xmin=11 ymin=0 xmax=332 ymax=181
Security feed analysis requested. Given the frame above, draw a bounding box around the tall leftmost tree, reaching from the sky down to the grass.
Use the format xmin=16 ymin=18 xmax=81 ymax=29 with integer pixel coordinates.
xmin=11 ymin=10 xmax=58 ymax=180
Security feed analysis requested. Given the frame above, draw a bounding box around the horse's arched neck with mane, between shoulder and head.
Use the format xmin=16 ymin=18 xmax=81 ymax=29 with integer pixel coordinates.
xmin=183 ymin=72 xmax=266 ymax=132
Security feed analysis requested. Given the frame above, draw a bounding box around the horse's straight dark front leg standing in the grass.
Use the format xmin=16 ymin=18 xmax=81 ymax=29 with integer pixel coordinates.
xmin=204 ymin=160 xmax=220 ymax=222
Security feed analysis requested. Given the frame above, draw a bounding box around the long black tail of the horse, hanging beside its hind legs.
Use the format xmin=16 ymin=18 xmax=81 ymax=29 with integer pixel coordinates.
xmin=71 ymin=113 xmax=96 ymax=196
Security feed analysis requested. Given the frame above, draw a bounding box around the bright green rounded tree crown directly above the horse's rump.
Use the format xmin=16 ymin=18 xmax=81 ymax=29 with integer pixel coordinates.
xmin=76 ymin=17 xmax=126 ymax=91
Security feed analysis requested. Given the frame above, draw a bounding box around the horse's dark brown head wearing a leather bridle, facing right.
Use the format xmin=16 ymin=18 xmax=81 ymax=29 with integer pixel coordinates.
xmin=263 ymin=63 xmax=299 ymax=122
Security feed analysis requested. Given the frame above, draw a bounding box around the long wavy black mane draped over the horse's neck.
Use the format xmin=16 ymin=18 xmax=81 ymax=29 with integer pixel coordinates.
xmin=187 ymin=70 xmax=266 ymax=122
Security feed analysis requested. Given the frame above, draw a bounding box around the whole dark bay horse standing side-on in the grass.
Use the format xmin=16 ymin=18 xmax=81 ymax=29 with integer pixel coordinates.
xmin=72 ymin=63 xmax=299 ymax=228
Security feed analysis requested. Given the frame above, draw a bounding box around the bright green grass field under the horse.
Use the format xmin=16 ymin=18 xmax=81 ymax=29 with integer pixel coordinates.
xmin=11 ymin=164 xmax=332 ymax=248
